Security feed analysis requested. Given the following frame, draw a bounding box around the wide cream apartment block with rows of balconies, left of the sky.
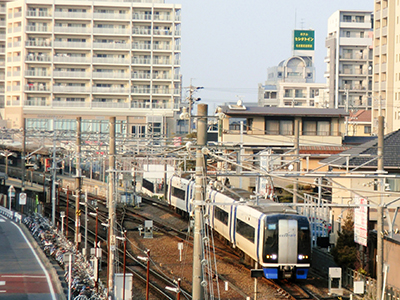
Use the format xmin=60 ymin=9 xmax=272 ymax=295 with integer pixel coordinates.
xmin=0 ymin=0 xmax=181 ymax=137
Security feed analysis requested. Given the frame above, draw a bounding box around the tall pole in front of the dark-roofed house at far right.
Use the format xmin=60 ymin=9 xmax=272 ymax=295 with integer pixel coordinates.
xmin=376 ymin=116 xmax=385 ymax=300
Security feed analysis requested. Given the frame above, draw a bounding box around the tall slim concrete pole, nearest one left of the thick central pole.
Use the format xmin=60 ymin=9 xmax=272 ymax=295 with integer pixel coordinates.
xmin=107 ymin=117 xmax=116 ymax=299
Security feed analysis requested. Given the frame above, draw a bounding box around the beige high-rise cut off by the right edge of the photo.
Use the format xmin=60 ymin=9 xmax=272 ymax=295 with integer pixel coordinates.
xmin=372 ymin=0 xmax=400 ymax=133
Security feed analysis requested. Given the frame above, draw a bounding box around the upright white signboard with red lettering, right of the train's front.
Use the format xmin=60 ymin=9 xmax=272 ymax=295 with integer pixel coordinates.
xmin=354 ymin=195 xmax=368 ymax=247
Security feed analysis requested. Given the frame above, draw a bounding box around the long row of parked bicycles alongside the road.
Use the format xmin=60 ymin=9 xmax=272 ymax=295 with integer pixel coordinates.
xmin=23 ymin=214 xmax=107 ymax=300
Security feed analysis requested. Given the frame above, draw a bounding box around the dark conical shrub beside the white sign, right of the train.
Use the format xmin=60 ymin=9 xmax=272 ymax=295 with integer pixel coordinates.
xmin=331 ymin=214 xmax=357 ymax=269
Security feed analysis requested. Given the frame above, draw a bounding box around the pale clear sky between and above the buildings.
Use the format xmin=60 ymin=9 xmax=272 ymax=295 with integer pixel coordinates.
xmin=165 ymin=0 xmax=374 ymax=112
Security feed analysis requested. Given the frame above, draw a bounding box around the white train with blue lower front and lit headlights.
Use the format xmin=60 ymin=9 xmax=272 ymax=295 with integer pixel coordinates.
xmin=166 ymin=176 xmax=311 ymax=279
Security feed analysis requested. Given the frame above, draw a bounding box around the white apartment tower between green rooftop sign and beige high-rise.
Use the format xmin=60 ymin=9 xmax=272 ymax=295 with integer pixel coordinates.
xmin=325 ymin=10 xmax=373 ymax=110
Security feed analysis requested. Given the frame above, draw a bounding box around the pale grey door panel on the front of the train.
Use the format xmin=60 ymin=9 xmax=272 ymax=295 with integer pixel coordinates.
xmin=278 ymin=219 xmax=297 ymax=264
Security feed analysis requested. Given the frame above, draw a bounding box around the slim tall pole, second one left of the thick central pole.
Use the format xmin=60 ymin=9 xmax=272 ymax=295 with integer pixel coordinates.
xmin=75 ymin=117 xmax=82 ymax=251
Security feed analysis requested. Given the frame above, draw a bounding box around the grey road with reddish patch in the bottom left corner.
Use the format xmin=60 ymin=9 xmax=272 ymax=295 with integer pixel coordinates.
xmin=0 ymin=216 xmax=57 ymax=300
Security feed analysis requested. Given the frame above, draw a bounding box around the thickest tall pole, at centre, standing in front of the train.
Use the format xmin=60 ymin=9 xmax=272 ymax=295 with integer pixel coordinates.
xmin=192 ymin=104 xmax=208 ymax=300
